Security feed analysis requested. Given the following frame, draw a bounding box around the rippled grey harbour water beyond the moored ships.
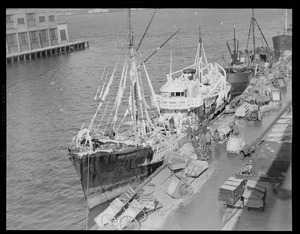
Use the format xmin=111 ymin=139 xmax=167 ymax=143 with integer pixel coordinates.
xmin=6 ymin=9 xmax=291 ymax=230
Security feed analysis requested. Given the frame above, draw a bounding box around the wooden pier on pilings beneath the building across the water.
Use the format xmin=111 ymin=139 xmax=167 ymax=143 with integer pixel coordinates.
xmin=6 ymin=40 xmax=89 ymax=64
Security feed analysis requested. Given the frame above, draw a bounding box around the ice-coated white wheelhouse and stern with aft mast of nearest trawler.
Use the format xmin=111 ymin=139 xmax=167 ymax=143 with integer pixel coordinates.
xmin=156 ymin=25 xmax=231 ymax=126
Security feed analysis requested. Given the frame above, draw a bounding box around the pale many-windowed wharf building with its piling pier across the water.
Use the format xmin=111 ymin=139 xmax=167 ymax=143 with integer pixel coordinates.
xmin=6 ymin=8 xmax=88 ymax=63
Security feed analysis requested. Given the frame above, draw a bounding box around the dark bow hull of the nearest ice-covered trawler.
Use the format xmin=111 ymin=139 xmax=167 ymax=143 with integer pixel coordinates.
xmin=69 ymin=147 xmax=156 ymax=208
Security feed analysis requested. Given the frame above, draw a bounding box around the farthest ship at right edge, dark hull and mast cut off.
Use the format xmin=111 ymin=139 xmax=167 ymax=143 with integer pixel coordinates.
xmin=272 ymin=9 xmax=292 ymax=60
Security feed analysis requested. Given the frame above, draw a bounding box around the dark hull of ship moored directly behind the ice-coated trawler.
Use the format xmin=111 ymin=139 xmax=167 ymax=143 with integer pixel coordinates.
xmin=226 ymin=71 xmax=251 ymax=97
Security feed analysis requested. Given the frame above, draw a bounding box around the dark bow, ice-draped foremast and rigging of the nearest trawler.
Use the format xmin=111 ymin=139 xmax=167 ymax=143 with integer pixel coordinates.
xmin=68 ymin=9 xmax=186 ymax=208
